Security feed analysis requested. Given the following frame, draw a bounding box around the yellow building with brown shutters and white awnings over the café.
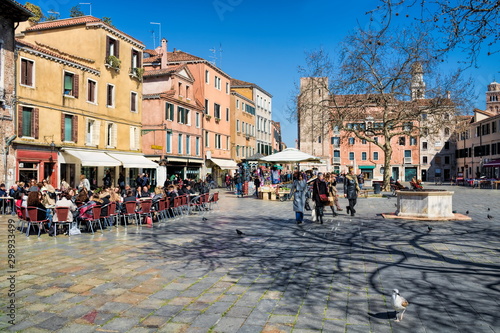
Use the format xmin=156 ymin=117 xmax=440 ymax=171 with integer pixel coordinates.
xmin=15 ymin=16 xmax=156 ymax=187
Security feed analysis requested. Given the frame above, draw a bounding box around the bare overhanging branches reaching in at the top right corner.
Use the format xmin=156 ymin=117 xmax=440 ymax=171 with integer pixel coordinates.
xmin=368 ymin=0 xmax=500 ymax=62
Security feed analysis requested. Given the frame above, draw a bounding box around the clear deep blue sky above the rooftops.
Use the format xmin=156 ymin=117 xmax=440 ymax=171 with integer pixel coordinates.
xmin=31 ymin=0 xmax=500 ymax=147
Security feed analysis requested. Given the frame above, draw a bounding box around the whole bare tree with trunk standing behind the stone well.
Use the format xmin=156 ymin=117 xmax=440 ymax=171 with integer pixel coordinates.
xmin=299 ymin=28 xmax=469 ymax=189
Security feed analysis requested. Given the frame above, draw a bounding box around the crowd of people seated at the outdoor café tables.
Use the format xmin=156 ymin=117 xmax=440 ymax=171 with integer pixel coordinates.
xmin=0 ymin=172 xmax=215 ymax=234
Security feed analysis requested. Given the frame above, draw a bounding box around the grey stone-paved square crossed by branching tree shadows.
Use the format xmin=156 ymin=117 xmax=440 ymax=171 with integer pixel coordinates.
xmin=0 ymin=186 xmax=500 ymax=333
